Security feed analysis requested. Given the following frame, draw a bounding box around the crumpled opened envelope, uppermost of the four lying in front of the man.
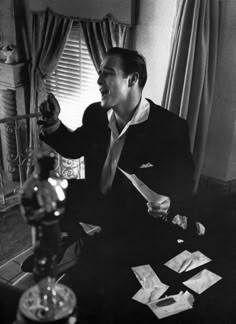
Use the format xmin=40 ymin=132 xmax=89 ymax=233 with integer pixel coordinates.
xmin=165 ymin=250 xmax=211 ymax=273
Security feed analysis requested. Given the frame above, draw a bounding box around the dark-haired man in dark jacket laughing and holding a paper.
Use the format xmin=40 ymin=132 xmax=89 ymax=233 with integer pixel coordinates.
xmin=35 ymin=48 xmax=193 ymax=266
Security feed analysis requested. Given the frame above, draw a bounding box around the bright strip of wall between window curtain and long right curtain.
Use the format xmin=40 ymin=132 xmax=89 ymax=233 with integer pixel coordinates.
xmin=133 ymin=0 xmax=177 ymax=104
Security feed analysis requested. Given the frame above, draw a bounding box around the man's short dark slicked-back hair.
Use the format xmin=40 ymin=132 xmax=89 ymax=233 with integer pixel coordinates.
xmin=105 ymin=47 xmax=147 ymax=89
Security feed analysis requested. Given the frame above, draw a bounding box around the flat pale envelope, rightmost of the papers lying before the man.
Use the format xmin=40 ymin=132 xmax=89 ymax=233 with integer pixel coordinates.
xmin=183 ymin=269 xmax=222 ymax=294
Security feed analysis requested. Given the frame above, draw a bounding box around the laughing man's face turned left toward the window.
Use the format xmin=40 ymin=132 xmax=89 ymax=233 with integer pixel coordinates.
xmin=97 ymin=55 xmax=130 ymax=109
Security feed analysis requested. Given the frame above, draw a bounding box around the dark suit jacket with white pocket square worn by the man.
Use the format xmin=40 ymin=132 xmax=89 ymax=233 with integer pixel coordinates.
xmin=41 ymin=100 xmax=194 ymax=237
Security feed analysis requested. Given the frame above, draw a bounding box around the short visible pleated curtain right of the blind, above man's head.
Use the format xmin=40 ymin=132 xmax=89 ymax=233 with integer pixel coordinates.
xmin=81 ymin=15 xmax=130 ymax=71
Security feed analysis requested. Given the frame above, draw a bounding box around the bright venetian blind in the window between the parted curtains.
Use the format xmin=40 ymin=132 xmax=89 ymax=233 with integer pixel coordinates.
xmin=46 ymin=22 xmax=100 ymax=130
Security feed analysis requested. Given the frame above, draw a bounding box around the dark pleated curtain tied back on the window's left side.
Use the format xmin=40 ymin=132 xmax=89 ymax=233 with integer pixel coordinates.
xmin=30 ymin=9 xmax=73 ymax=161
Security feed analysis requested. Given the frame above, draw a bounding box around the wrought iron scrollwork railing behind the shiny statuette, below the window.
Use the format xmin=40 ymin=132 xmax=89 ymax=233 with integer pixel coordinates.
xmin=0 ymin=113 xmax=85 ymax=210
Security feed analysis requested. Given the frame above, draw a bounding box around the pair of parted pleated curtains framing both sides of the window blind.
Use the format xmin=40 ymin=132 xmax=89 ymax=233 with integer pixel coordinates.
xmin=29 ymin=9 xmax=130 ymax=176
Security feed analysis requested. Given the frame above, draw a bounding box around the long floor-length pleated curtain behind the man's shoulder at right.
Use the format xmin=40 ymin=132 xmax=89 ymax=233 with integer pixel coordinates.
xmin=162 ymin=0 xmax=220 ymax=191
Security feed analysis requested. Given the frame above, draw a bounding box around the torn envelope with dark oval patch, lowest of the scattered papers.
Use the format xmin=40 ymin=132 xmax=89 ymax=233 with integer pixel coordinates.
xmin=148 ymin=291 xmax=194 ymax=319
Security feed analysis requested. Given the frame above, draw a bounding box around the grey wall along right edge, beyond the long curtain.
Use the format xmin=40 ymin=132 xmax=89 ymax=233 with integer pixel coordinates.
xmin=203 ymin=0 xmax=236 ymax=181
